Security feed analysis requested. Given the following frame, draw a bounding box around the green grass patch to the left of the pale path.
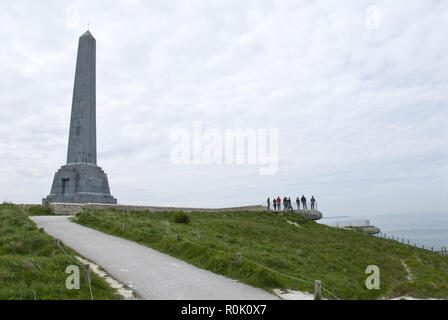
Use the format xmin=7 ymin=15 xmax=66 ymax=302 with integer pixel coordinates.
xmin=0 ymin=205 xmax=120 ymax=300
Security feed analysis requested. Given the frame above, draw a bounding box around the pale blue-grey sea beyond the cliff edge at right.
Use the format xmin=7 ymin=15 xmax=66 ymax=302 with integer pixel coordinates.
xmin=319 ymin=212 xmax=448 ymax=251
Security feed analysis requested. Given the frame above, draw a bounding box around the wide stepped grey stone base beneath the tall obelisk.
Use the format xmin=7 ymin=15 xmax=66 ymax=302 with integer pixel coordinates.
xmin=42 ymin=163 xmax=117 ymax=204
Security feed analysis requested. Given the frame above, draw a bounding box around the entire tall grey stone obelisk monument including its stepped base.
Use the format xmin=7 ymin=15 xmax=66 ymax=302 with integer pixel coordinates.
xmin=43 ymin=31 xmax=117 ymax=204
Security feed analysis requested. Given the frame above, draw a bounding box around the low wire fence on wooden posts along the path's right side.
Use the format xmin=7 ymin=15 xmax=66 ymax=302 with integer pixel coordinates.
xmin=117 ymin=220 xmax=340 ymax=300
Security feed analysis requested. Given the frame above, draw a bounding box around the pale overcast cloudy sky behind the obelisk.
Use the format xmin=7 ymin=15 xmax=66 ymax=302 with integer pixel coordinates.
xmin=0 ymin=0 xmax=448 ymax=216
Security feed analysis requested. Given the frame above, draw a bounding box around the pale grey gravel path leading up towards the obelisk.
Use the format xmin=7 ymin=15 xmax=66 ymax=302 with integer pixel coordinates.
xmin=30 ymin=216 xmax=279 ymax=300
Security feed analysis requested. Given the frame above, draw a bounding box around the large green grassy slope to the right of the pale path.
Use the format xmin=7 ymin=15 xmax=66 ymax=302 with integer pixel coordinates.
xmin=76 ymin=210 xmax=448 ymax=299
